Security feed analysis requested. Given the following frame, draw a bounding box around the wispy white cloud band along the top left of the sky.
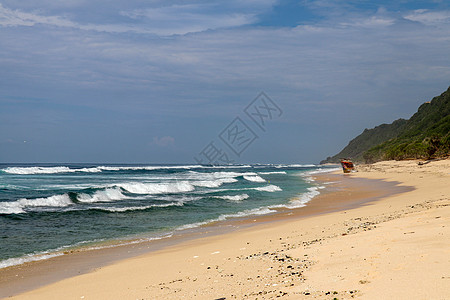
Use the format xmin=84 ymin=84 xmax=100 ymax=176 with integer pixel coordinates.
xmin=0 ymin=0 xmax=275 ymax=36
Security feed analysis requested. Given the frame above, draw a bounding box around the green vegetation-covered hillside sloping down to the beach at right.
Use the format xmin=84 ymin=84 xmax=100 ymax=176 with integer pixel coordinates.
xmin=321 ymin=87 xmax=450 ymax=163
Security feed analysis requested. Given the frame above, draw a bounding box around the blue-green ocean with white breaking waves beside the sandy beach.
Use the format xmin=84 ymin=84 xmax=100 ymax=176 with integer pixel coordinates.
xmin=0 ymin=164 xmax=334 ymax=268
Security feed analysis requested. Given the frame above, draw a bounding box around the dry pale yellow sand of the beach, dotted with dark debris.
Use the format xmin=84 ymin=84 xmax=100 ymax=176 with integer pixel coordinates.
xmin=7 ymin=160 xmax=450 ymax=299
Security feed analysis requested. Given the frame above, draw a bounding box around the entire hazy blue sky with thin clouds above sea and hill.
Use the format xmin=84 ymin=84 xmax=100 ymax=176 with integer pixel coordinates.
xmin=0 ymin=0 xmax=450 ymax=163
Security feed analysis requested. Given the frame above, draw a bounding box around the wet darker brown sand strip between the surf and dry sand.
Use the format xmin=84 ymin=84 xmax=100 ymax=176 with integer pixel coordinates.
xmin=0 ymin=173 xmax=407 ymax=298
